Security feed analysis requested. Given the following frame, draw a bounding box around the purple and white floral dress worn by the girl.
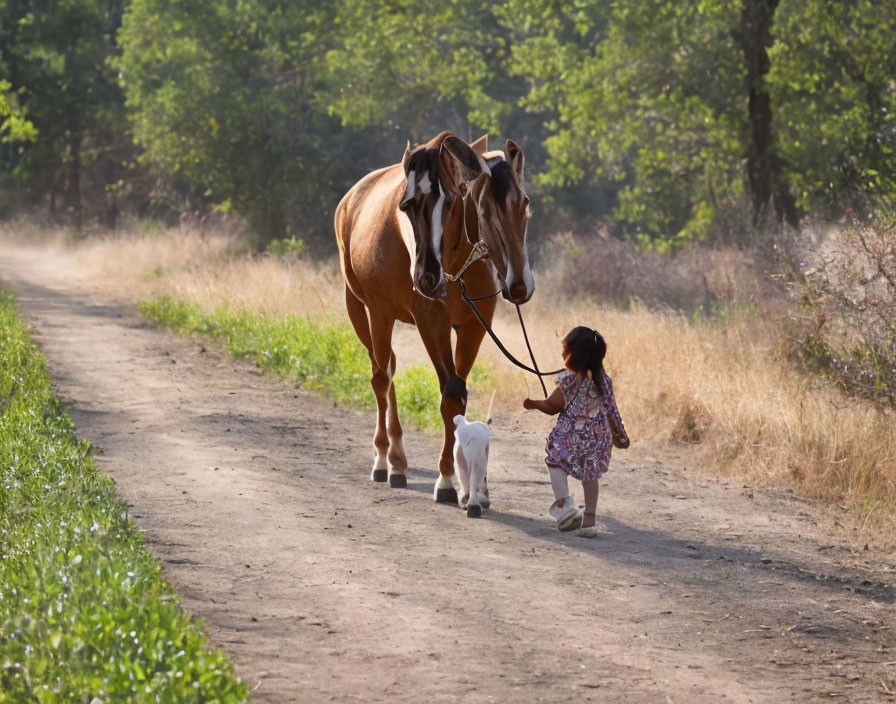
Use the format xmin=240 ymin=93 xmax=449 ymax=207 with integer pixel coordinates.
xmin=545 ymin=372 xmax=628 ymax=481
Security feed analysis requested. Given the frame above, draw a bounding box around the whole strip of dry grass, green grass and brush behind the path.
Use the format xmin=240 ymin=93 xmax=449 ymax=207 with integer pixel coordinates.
xmin=29 ymin=227 xmax=896 ymax=531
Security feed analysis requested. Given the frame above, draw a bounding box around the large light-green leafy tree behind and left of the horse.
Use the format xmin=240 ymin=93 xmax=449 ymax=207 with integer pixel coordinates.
xmin=117 ymin=0 xmax=382 ymax=242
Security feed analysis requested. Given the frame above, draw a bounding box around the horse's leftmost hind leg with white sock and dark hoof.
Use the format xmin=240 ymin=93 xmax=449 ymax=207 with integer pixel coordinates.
xmin=345 ymin=286 xmax=404 ymax=482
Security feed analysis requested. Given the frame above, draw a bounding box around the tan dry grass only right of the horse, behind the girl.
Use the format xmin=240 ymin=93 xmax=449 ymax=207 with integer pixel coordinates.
xmin=512 ymin=278 xmax=896 ymax=527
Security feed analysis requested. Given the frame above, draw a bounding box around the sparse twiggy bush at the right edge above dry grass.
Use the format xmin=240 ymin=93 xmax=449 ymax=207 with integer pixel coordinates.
xmin=801 ymin=214 xmax=896 ymax=408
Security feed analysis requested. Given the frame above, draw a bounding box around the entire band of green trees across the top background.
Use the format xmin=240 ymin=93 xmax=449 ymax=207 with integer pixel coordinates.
xmin=0 ymin=0 xmax=896 ymax=243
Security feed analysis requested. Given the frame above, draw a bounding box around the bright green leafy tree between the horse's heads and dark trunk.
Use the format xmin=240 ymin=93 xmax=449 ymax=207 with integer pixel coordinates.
xmin=504 ymin=0 xmax=746 ymax=241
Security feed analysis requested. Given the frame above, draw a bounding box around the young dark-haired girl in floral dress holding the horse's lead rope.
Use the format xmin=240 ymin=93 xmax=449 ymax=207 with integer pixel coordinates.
xmin=523 ymin=326 xmax=629 ymax=538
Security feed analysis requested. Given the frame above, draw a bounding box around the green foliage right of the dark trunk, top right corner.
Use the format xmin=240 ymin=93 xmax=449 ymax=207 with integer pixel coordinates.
xmin=769 ymin=0 xmax=896 ymax=214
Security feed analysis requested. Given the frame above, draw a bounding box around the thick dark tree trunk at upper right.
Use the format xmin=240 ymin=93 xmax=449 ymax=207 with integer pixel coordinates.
xmin=737 ymin=0 xmax=799 ymax=227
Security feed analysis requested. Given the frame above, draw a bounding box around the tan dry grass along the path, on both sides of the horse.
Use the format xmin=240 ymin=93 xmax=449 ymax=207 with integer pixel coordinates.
xmin=8 ymin=223 xmax=896 ymax=529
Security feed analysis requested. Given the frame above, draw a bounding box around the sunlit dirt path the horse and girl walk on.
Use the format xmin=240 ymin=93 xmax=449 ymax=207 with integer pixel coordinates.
xmin=0 ymin=245 xmax=896 ymax=704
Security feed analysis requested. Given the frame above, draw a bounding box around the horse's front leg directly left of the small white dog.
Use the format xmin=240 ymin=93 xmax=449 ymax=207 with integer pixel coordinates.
xmin=411 ymin=296 xmax=467 ymax=503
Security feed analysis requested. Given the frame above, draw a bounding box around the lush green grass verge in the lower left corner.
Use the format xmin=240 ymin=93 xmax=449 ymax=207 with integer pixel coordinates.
xmin=0 ymin=292 xmax=248 ymax=704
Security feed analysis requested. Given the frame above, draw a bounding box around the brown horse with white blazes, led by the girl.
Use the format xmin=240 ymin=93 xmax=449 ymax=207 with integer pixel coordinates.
xmin=335 ymin=132 xmax=535 ymax=502
